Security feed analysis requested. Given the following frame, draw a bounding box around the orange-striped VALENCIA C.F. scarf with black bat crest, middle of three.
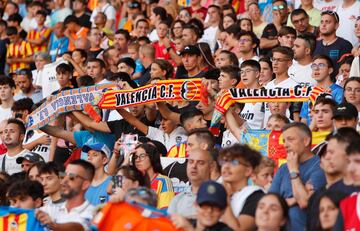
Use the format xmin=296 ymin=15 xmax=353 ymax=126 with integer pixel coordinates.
xmin=98 ymin=79 xmax=201 ymax=109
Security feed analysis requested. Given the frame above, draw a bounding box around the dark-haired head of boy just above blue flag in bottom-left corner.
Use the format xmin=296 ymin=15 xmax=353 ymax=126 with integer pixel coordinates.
xmin=7 ymin=180 xmax=44 ymax=209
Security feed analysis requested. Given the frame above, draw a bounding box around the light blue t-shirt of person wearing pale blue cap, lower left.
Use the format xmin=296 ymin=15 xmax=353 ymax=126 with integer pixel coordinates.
xmin=85 ymin=176 xmax=111 ymax=206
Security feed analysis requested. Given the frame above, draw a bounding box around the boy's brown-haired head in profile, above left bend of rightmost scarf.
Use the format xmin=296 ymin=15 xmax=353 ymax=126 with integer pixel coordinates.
xmin=219 ymin=65 xmax=240 ymax=90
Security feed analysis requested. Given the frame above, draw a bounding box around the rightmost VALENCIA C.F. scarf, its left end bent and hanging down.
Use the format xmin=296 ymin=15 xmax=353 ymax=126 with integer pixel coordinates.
xmin=209 ymin=86 xmax=324 ymax=136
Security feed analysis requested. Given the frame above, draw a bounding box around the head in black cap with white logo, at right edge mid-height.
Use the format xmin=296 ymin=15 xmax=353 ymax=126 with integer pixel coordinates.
xmin=333 ymin=103 xmax=359 ymax=130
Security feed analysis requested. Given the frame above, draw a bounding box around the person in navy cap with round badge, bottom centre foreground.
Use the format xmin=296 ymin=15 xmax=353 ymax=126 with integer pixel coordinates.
xmin=171 ymin=181 xmax=233 ymax=231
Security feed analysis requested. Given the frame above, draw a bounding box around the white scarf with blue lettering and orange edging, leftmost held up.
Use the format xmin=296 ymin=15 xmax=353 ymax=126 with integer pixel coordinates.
xmin=26 ymin=84 xmax=116 ymax=130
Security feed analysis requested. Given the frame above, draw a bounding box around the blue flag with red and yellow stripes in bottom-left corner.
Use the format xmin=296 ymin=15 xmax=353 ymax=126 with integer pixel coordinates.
xmin=0 ymin=206 xmax=45 ymax=231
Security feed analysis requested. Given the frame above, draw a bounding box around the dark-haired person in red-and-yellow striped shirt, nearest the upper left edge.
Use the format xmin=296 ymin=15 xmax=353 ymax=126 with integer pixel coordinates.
xmin=6 ymin=27 xmax=34 ymax=73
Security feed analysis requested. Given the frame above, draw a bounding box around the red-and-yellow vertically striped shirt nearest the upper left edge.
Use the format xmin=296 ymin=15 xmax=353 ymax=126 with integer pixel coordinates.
xmin=6 ymin=41 xmax=34 ymax=73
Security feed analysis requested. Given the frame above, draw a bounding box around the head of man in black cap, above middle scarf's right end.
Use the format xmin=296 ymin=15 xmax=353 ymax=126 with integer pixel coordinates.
xmin=180 ymin=45 xmax=204 ymax=79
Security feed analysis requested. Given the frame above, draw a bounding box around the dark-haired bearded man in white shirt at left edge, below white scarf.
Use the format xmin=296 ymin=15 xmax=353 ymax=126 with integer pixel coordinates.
xmin=0 ymin=119 xmax=29 ymax=175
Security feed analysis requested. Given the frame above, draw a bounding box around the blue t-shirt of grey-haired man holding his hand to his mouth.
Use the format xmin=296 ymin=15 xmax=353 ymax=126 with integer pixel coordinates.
xmin=269 ymin=156 xmax=326 ymax=231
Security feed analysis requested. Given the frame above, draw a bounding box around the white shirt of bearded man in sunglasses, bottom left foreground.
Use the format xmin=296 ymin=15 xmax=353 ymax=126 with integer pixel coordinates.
xmin=40 ymin=201 xmax=95 ymax=230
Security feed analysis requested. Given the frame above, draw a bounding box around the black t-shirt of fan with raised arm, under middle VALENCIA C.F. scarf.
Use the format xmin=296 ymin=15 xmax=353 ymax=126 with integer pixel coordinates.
xmin=106 ymin=116 xmax=154 ymax=140
